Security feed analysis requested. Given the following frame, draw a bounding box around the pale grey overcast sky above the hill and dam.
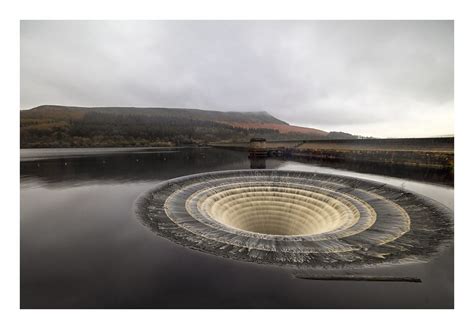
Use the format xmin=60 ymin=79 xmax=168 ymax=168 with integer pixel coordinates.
xmin=20 ymin=21 xmax=454 ymax=137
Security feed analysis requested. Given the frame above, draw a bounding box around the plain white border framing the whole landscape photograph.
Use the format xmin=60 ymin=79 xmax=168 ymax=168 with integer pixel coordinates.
xmin=0 ymin=0 xmax=474 ymax=329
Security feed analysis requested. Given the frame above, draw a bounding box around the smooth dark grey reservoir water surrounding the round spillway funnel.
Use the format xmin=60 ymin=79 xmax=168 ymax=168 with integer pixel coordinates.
xmin=20 ymin=149 xmax=454 ymax=308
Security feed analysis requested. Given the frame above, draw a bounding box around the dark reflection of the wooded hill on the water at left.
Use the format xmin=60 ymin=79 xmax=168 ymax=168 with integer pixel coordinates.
xmin=20 ymin=148 xmax=262 ymax=187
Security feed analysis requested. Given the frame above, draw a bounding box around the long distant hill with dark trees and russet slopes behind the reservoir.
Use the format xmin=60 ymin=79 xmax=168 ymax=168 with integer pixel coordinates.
xmin=20 ymin=105 xmax=352 ymax=148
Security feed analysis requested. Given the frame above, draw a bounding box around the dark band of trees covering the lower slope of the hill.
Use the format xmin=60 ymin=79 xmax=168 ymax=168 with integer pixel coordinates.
xmin=20 ymin=112 xmax=301 ymax=148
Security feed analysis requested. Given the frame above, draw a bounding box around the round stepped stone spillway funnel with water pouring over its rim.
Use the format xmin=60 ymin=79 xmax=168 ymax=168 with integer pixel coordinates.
xmin=135 ymin=170 xmax=453 ymax=268
